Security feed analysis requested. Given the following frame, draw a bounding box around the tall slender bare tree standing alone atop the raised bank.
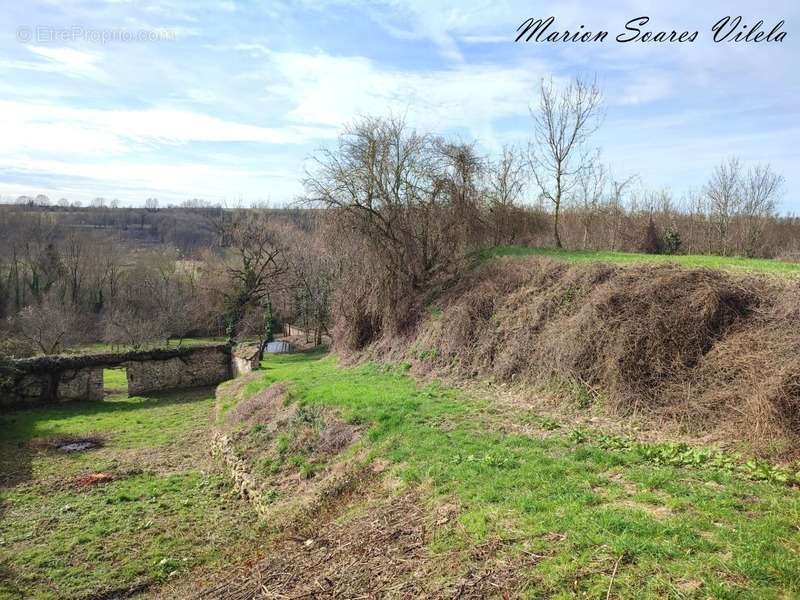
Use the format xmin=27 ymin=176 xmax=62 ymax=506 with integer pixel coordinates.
xmin=529 ymin=78 xmax=602 ymax=248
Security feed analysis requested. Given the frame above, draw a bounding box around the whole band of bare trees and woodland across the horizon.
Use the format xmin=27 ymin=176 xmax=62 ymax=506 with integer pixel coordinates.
xmin=0 ymin=80 xmax=800 ymax=355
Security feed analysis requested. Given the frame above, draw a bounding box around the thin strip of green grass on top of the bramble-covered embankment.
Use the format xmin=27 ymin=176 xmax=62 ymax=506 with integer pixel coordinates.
xmin=480 ymin=246 xmax=800 ymax=277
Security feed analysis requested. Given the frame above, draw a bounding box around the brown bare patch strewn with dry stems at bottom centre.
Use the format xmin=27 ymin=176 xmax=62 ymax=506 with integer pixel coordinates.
xmin=198 ymin=493 xmax=538 ymax=600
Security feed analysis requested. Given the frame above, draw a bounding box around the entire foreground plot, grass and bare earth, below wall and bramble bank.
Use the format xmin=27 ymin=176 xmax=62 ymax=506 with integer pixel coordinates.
xmin=0 ymin=352 xmax=800 ymax=598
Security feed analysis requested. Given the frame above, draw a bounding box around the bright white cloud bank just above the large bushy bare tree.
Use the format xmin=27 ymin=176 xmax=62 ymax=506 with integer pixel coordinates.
xmin=267 ymin=52 xmax=549 ymax=143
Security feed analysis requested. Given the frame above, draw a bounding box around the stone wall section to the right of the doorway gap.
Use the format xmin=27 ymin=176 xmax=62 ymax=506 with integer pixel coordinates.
xmin=125 ymin=346 xmax=231 ymax=396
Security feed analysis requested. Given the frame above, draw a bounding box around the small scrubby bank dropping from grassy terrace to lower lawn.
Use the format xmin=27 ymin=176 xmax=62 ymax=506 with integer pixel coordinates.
xmin=213 ymin=373 xmax=364 ymax=527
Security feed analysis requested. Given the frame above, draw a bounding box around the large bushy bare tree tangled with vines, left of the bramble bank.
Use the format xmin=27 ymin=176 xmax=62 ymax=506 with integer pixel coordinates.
xmin=305 ymin=118 xmax=482 ymax=339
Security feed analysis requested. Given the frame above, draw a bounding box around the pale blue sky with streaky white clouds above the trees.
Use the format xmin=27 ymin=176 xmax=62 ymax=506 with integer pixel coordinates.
xmin=0 ymin=0 xmax=800 ymax=213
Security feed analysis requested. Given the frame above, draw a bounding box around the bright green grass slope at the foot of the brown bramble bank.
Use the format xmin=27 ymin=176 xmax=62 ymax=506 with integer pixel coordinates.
xmin=250 ymin=355 xmax=800 ymax=598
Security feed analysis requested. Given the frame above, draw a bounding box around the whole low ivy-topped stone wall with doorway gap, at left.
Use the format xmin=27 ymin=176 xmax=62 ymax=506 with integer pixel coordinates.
xmin=0 ymin=344 xmax=233 ymax=406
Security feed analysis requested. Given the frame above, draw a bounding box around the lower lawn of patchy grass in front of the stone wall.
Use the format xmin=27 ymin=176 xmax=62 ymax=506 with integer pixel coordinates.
xmin=0 ymin=378 xmax=268 ymax=598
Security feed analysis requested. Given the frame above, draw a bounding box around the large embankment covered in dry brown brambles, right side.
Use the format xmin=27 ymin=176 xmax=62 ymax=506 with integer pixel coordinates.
xmin=339 ymin=258 xmax=800 ymax=456
